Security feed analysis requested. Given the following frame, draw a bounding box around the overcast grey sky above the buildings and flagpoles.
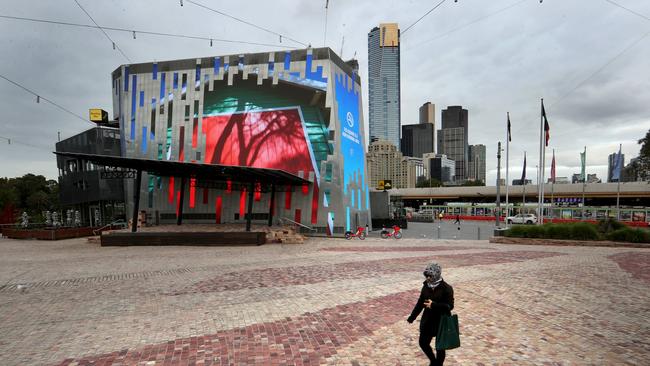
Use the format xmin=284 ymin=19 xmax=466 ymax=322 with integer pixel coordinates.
xmin=0 ymin=0 xmax=650 ymax=185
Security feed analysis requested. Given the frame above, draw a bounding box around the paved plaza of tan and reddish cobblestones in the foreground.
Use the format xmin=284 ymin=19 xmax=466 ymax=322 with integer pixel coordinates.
xmin=0 ymin=231 xmax=650 ymax=366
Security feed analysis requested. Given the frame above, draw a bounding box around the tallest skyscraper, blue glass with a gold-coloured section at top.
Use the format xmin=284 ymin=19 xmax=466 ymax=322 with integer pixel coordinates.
xmin=368 ymin=23 xmax=401 ymax=150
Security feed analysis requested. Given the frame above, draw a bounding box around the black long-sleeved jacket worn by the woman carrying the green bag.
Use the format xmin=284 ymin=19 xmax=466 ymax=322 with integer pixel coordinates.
xmin=408 ymin=280 xmax=454 ymax=335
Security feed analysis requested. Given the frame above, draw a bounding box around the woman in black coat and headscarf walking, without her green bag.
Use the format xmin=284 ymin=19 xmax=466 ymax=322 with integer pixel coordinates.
xmin=407 ymin=263 xmax=454 ymax=366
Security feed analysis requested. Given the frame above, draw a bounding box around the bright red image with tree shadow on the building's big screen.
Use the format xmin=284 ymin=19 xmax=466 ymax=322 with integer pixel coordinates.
xmin=203 ymin=108 xmax=314 ymax=177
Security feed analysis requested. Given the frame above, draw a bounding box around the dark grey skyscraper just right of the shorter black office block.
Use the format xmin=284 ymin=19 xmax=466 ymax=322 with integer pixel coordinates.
xmin=438 ymin=106 xmax=469 ymax=183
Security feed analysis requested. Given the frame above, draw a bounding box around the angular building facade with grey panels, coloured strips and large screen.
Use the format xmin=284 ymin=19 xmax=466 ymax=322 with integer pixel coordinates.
xmin=112 ymin=48 xmax=370 ymax=234
